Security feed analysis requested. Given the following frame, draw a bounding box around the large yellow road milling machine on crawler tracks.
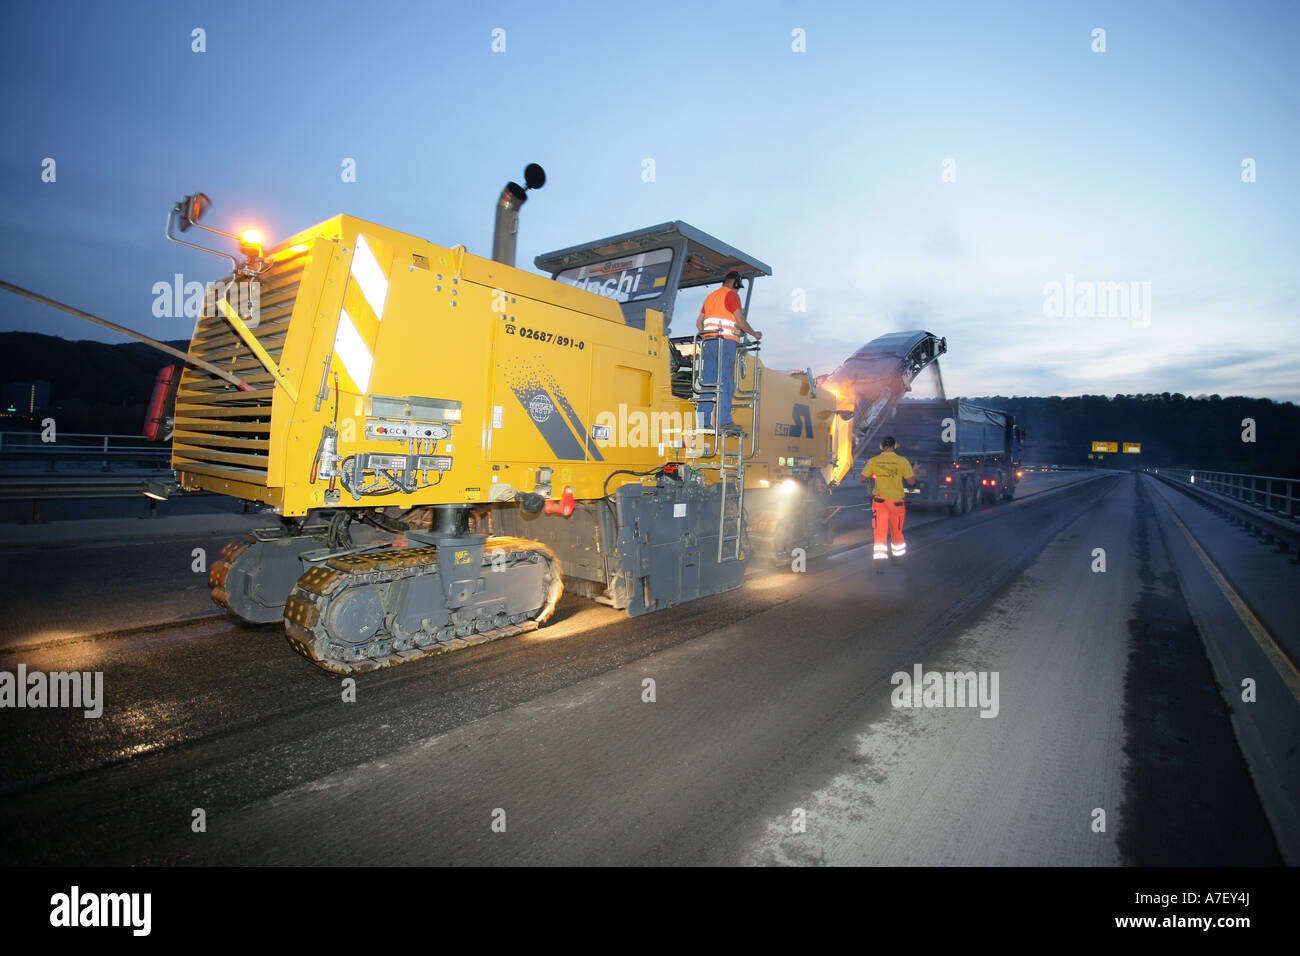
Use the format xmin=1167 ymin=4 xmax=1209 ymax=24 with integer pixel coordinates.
xmin=142 ymin=165 xmax=873 ymax=672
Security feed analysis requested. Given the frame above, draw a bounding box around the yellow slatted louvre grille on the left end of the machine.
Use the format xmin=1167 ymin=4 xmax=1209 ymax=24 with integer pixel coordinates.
xmin=172 ymin=256 xmax=307 ymax=485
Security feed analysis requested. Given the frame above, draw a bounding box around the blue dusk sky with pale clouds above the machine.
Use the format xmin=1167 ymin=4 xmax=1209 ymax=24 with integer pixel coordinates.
xmin=0 ymin=0 xmax=1300 ymax=401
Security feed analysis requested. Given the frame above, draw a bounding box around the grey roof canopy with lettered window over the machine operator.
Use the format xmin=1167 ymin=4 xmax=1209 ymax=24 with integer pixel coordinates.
xmin=533 ymin=220 xmax=772 ymax=330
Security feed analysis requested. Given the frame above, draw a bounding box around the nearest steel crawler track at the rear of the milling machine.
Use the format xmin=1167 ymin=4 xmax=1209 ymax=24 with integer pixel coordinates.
xmin=285 ymin=537 xmax=564 ymax=674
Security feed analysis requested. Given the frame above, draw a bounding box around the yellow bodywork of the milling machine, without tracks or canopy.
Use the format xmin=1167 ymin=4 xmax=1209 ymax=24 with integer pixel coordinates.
xmin=172 ymin=216 xmax=846 ymax=518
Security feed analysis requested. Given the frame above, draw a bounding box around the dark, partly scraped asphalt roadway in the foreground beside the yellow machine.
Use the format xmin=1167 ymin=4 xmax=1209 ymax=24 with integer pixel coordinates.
xmin=0 ymin=475 xmax=1294 ymax=864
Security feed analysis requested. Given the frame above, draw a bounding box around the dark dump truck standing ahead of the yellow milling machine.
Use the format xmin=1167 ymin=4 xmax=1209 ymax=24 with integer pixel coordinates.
xmin=881 ymin=399 xmax=1024 ymax=515
